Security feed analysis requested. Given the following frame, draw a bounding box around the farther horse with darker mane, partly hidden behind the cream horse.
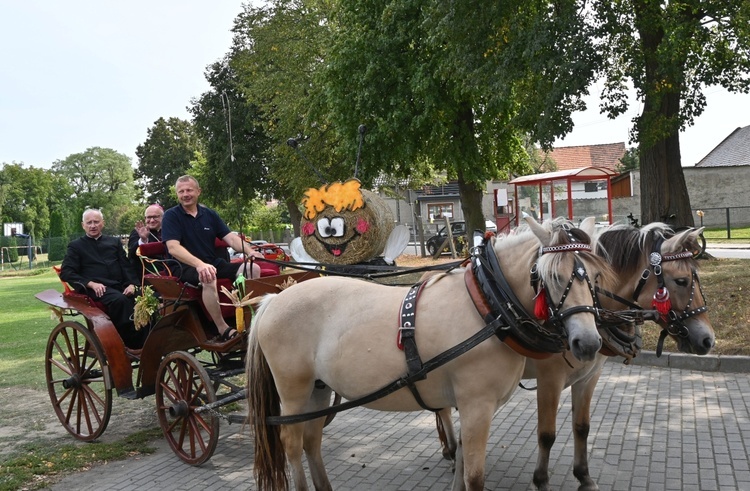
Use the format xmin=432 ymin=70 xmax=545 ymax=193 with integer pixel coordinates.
xmin=437 ymin=221 xmax=715 ymax=491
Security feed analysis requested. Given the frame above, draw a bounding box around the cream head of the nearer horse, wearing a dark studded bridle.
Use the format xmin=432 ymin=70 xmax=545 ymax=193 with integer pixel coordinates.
xmin=526 ymin=218 xmax=612 ymax=361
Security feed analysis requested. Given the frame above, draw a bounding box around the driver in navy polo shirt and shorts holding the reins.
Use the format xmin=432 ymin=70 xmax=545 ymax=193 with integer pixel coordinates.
xmin=161 ymin=176 xmax=260 ymax=341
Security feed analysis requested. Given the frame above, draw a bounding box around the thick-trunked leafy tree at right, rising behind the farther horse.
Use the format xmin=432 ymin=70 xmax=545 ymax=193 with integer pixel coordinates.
xmin=593 ymin=0 xmax=750 ymax=226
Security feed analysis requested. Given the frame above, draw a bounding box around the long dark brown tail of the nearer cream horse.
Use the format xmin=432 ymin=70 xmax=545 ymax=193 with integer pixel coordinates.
xmin=246 ymin=295 xmax=289 ymax=490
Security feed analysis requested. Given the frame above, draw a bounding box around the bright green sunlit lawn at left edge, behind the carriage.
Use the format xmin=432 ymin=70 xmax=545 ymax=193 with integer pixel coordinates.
xmin=0 ymin=269 xmax=62 ymax=390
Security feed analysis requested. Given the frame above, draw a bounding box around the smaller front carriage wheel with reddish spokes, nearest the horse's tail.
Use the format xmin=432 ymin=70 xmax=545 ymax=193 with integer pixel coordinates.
xmin=155 ymin=351 xmax=219 ymax=465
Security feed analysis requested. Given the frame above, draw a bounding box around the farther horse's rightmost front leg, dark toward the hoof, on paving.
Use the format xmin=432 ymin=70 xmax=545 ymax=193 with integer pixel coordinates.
xmin=570 ymin=368 xmax=601 ymax=491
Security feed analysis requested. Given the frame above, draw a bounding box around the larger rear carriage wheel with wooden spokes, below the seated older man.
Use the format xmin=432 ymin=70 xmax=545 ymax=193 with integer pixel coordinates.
xmin=44 ymin=321 xmax=112 ymax=441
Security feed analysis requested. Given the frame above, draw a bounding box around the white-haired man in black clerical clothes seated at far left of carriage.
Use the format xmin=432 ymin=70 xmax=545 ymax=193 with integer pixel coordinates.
xmin=60 ymin=209 xmax=148 ymax=349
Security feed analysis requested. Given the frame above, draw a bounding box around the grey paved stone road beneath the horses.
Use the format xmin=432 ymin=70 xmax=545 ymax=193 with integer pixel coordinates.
xmin=52 ymin=363 xmax=750 ymax=491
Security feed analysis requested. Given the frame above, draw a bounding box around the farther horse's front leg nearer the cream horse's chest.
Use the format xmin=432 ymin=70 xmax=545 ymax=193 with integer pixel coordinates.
xmin=534 ymin=372 xmax=565 ymax=491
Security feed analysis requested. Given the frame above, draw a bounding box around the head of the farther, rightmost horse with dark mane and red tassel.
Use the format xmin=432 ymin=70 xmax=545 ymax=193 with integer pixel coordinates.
xmin=597 ymin=222 xmax=715 ymax=355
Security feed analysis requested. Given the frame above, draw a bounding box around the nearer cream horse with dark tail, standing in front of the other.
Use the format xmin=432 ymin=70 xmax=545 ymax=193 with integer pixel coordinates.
xmin=247 ymin=222 xmax=613 ymax=490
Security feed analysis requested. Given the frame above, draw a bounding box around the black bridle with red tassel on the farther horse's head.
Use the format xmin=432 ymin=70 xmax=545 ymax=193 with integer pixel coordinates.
xmin=596 ymin=237 xmax=708 ymax=357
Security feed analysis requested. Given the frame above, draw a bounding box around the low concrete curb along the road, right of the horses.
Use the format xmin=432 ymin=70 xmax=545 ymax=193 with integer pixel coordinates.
xmin=608 ymin=350 xmax=750 ymax=373
